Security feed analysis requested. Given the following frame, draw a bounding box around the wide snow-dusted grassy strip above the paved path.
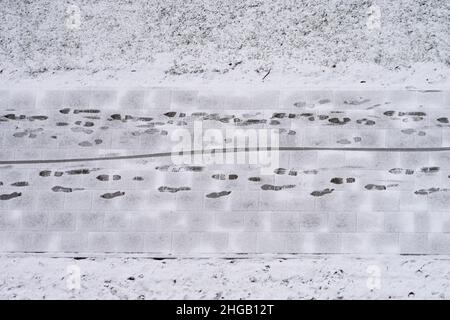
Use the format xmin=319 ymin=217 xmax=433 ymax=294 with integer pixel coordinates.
xmin=0 ymin=0 xmax=450 ymax=88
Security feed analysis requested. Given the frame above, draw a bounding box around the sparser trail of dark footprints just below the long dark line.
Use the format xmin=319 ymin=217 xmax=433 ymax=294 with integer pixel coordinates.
xmin=0 ymin=165 xmax=450 ymax=201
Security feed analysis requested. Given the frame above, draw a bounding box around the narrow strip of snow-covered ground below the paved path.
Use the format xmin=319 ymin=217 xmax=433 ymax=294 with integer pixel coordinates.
xmin=0 ymin=255 xmax=450 ymax=299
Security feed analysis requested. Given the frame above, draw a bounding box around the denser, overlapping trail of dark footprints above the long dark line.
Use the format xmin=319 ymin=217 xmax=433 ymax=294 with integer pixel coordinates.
xmin=0 ymin=107 xmax=450 ymax=148
